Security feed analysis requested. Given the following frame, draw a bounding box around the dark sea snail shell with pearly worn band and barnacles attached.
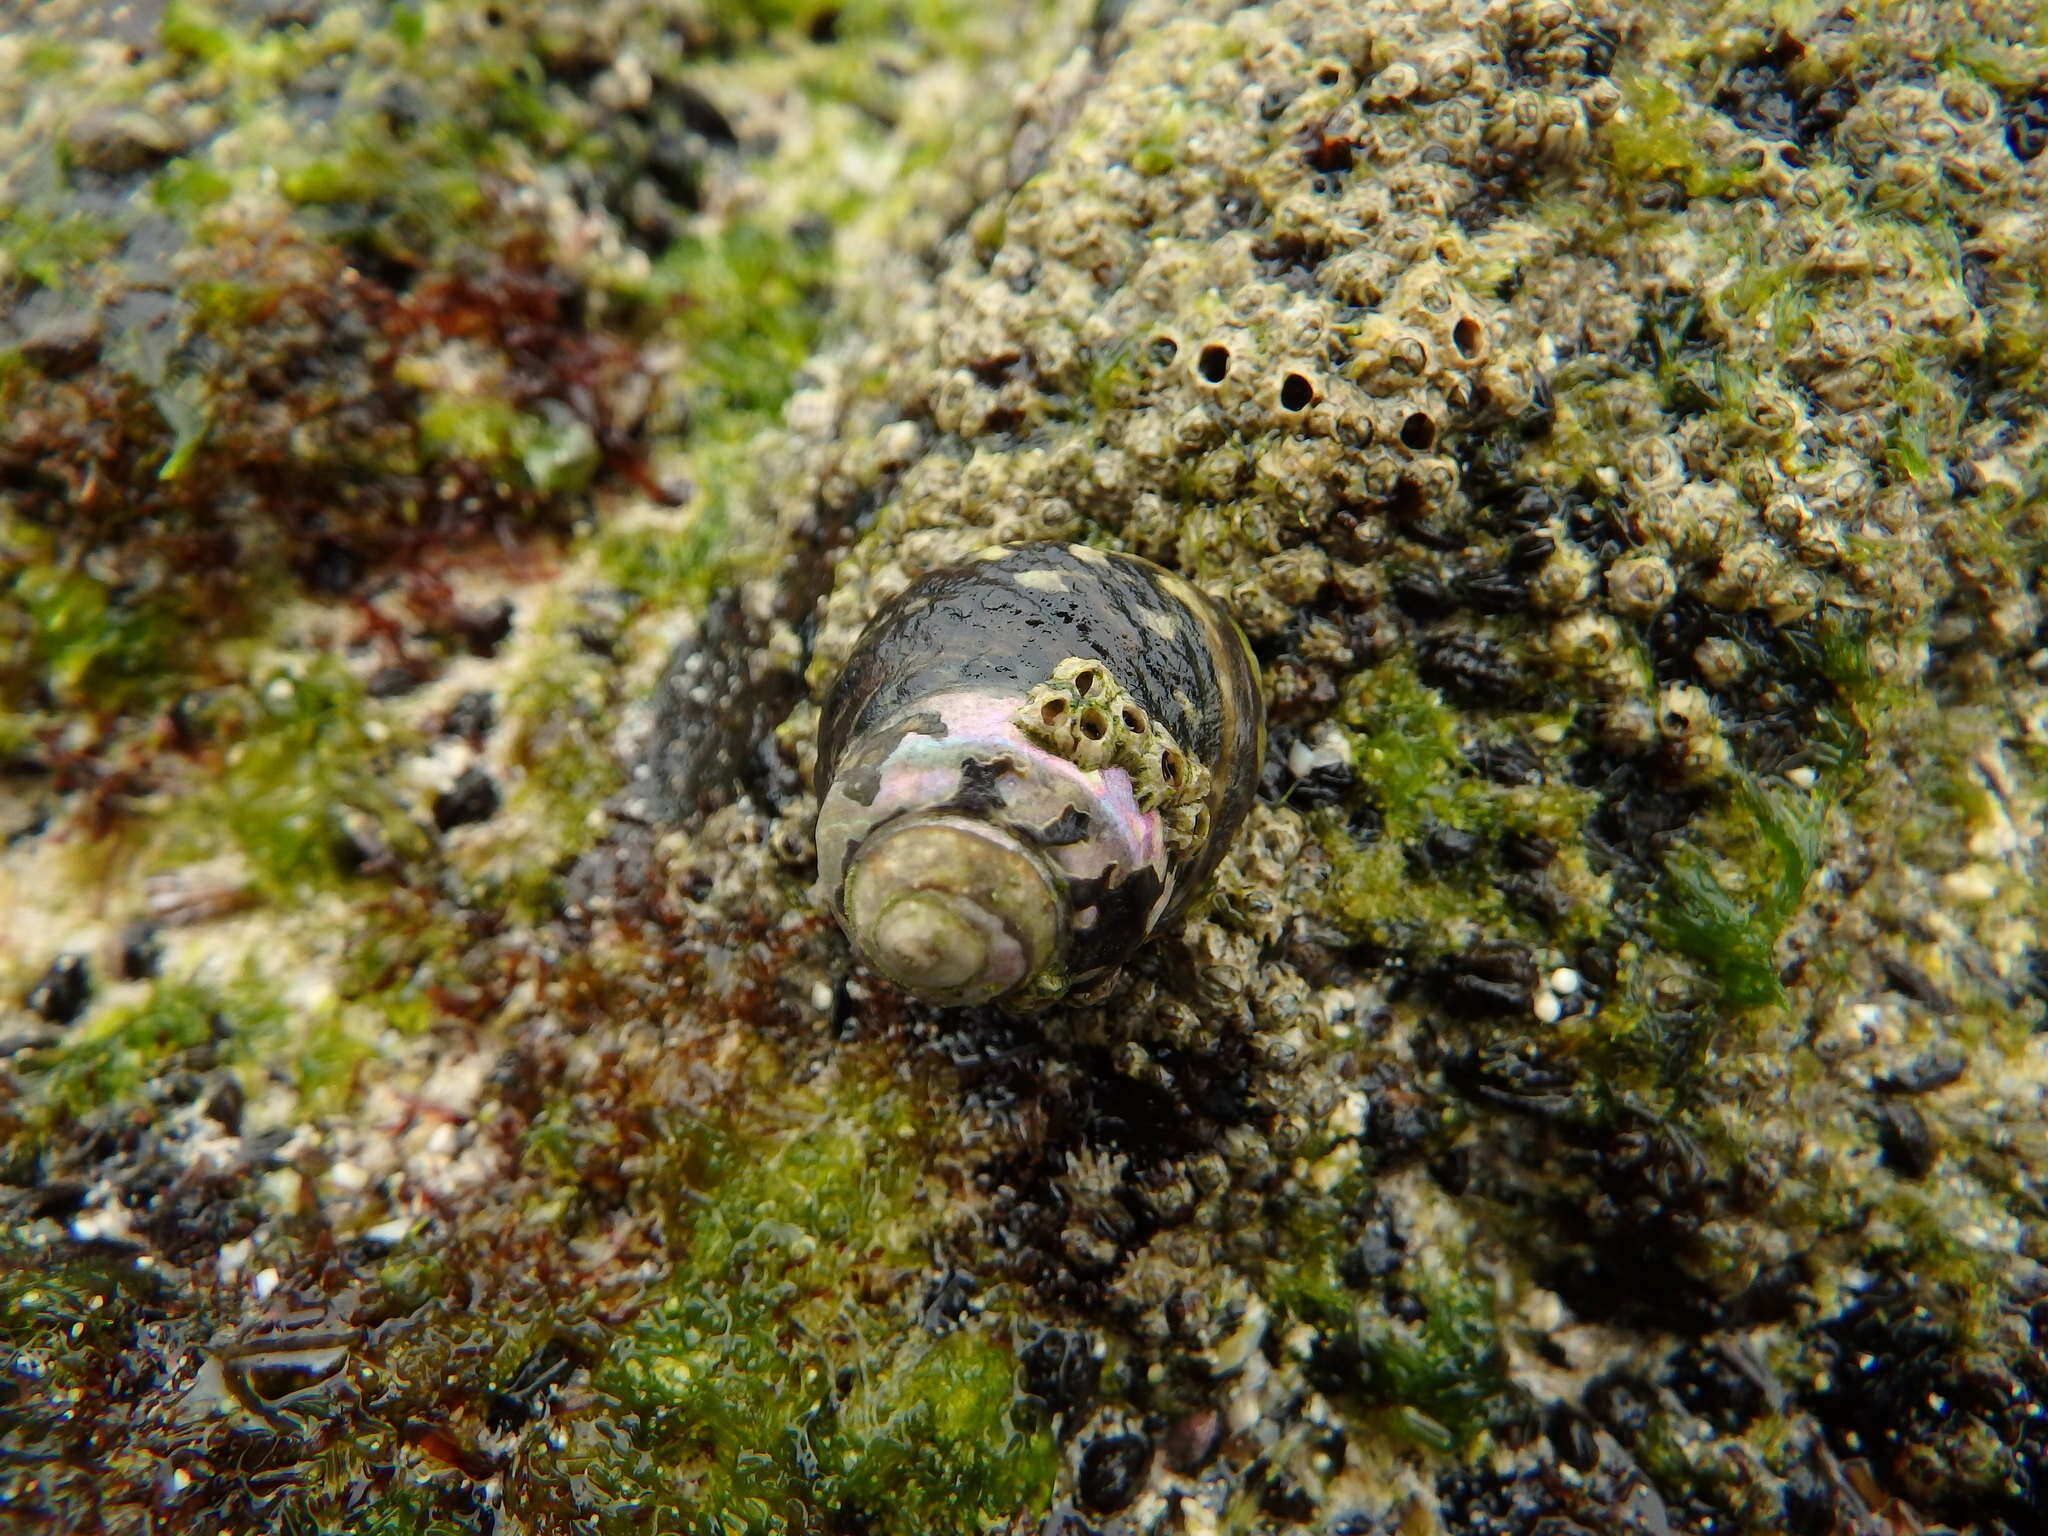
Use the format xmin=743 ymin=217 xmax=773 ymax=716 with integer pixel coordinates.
xmin=817 ymin=545 xmax=1266 ymax=1008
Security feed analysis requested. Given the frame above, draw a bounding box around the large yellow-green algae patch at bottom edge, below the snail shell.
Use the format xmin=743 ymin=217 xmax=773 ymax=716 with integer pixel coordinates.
xmin=530 ymin=1094 xmax=1053 ymax=1536
